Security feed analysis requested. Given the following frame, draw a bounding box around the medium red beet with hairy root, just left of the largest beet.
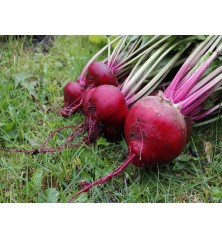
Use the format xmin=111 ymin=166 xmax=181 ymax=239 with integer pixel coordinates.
xmin=83 ymin=85 xmax=128 ymax=142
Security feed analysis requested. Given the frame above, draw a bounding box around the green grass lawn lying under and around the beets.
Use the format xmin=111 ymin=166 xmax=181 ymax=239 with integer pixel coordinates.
xmin=0 ymin=36 xmax=222 ymax=203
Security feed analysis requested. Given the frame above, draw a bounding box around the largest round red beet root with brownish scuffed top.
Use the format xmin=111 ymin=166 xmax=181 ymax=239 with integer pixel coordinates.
xmin=124 ymin=96 xmax=187 ymax=167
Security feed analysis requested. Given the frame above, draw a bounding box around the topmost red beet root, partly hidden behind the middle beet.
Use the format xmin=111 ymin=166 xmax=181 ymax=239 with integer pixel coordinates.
xmin=86 ymin=61 xmax=118 ymax=87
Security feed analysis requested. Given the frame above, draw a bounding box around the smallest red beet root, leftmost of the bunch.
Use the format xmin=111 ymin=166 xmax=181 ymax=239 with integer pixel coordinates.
xmin=61 ymin=82 xmax=84 ymax=117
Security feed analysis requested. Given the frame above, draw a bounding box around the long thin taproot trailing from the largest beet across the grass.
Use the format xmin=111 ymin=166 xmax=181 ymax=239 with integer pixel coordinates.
xmin=67 ymin=154 xmax=137 ymax=203
